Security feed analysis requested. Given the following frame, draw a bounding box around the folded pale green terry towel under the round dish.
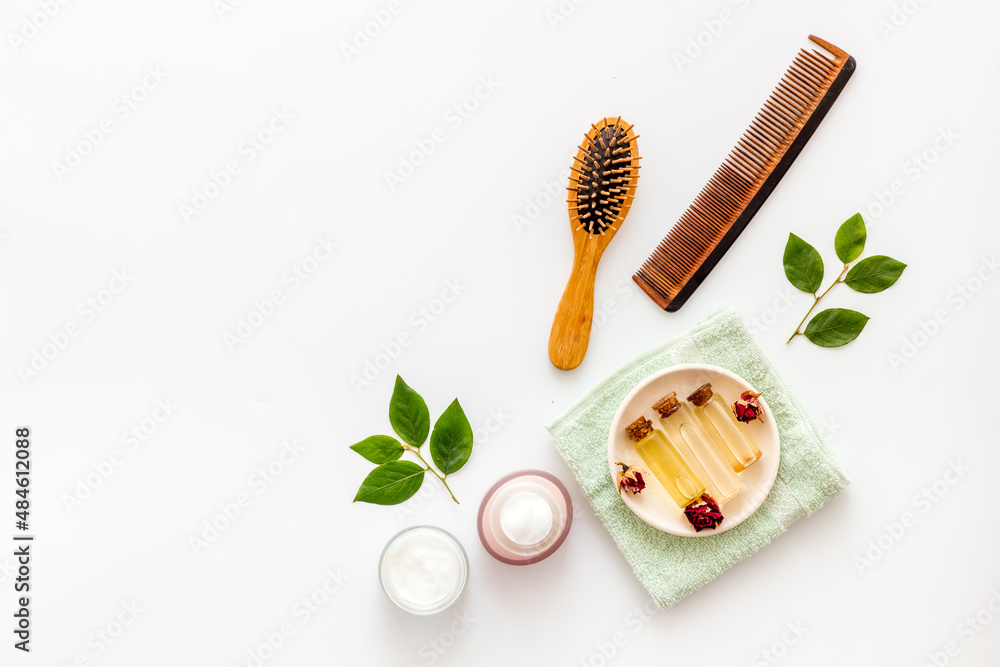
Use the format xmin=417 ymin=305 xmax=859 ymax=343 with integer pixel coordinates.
xmin=546 ymin=308 xmax=849 ymax=607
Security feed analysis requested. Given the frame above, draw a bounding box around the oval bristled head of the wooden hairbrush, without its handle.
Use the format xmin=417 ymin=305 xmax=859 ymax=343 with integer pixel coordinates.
xmin=566 ymin=117 xmax=639 ymax=234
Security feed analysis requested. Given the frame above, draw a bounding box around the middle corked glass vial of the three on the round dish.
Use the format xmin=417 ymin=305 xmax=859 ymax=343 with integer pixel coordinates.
xmin=653 ymin=392 xmax=744 ymax=505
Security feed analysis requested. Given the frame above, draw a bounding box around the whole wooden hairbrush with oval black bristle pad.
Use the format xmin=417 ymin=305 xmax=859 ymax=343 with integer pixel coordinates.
xmin=549 ymin=116 xmax=639 ymax=370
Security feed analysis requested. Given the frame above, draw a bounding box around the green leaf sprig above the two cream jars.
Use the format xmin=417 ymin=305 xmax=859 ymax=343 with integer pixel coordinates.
xmin=351 ymin=375 xmax=472 ymax=505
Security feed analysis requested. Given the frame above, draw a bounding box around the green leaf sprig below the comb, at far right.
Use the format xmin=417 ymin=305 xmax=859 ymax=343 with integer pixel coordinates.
xmin=783 ymin=213 xmax=906 ymax=347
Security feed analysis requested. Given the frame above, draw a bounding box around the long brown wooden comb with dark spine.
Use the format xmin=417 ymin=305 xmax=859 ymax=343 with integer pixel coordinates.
xmin=632 ymin=35 xmax=856 ymax=312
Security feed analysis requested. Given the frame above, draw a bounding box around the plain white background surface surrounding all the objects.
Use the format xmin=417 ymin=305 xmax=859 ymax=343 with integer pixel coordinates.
xmin=0 ymin=0 xmax=1000 ymax=667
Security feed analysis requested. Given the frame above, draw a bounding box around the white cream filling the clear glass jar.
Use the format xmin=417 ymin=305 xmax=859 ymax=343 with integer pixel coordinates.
xmin=384 ymin=528 xmax=465 ymax=607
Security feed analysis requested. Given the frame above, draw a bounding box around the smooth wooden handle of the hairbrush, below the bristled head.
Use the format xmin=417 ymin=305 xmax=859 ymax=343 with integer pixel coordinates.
xmin=549 ymin=244 xmax=607 ymax=371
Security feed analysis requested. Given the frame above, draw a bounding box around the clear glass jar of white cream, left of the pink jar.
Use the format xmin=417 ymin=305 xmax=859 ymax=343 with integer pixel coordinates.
xmin=378 ymin=526 xmax=469 ymax=614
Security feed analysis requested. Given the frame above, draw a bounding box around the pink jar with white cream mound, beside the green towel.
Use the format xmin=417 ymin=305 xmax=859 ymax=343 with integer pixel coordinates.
xmin=479 ymin=470 xmax=573 ymax=565
